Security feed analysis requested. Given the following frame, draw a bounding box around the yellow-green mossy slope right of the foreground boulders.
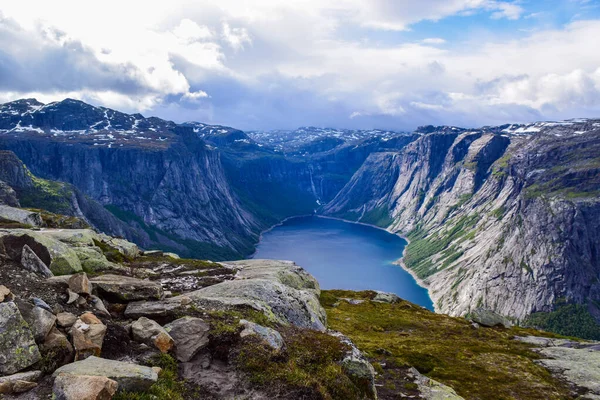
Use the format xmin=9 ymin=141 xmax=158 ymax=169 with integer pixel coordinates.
xmin=321 ymin=291 xmax=572 ymax=400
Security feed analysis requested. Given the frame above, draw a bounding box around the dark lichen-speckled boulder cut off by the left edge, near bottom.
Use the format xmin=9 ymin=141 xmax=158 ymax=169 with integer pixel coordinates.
xmin=0 ymin=302 xmax=40 ymax=375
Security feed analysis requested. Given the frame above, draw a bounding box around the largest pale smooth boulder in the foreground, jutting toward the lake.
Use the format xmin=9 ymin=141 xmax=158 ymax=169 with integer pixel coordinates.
xmin=180 ymin=260 xmax=327 ymax=331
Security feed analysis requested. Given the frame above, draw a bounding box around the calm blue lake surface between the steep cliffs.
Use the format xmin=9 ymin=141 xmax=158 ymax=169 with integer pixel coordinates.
xmin=253 ymin=217 xmax=433 ymax=310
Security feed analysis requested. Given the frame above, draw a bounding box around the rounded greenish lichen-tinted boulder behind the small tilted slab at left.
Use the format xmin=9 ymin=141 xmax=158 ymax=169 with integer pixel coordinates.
xmin=2 ymin=229 xmax=81 ymax=275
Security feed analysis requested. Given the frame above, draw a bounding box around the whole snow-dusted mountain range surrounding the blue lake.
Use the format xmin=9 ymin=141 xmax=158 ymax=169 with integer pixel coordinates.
xmin=0 ymin=99 xmax=600 ymax=333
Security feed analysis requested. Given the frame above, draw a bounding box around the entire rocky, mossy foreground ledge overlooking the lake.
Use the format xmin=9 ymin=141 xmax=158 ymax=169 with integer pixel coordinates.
xmin=0 ymin=223 xmax=600 ymax=400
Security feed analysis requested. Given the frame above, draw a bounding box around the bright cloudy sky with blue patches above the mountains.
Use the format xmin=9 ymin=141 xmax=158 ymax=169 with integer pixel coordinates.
xmin=0 ymin=0 xmax=600 ymax=130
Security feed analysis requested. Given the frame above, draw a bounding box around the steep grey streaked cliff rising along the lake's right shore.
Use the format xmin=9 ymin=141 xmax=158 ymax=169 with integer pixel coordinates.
xmin=324 ymin=121 xmax=600 ymax=319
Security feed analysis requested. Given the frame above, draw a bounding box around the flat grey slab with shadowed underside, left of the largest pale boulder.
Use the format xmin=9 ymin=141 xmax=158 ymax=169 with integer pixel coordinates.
xmin=91 ymin=274 xmax=163 ymax=301
